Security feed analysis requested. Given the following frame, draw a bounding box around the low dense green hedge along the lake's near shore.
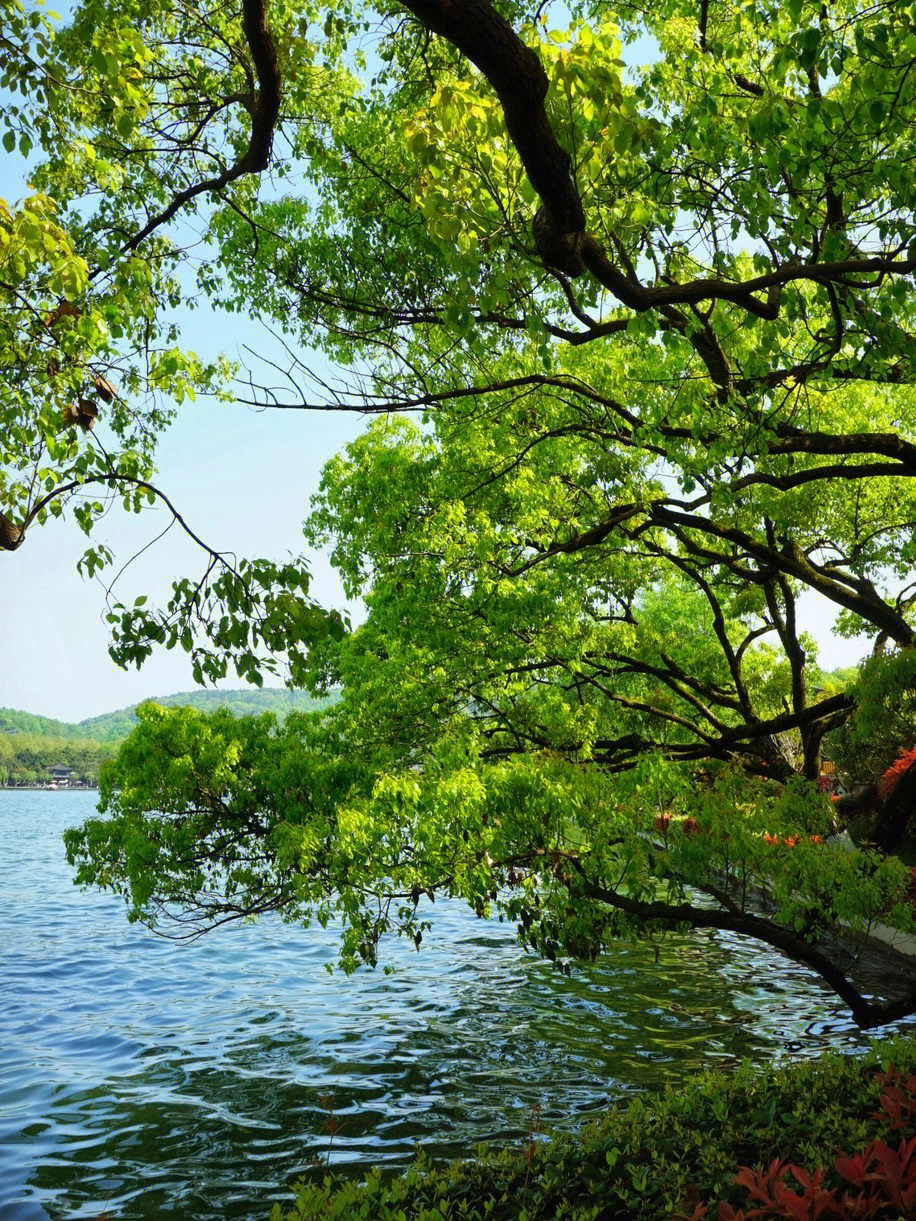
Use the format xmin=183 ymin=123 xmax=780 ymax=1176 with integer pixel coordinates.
xmin=274 ymin=1039 xmax=916 ymax=1221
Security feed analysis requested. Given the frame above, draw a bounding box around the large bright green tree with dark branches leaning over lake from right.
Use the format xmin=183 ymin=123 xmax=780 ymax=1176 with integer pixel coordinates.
xmin=17 ymin=0 xmax=916 ymax=1024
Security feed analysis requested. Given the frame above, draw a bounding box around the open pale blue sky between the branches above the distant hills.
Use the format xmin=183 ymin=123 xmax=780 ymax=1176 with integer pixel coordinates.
xmin=0 ymin=293 xmax=364 ymax=720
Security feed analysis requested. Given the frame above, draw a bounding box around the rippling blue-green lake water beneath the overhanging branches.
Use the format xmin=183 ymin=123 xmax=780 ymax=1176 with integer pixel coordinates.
xmin=0 ymin=791 xmax=913 ymax=1221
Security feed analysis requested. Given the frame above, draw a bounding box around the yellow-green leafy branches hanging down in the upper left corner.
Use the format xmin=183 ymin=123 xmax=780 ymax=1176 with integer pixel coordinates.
xmin=0 ymin=0 xmax=342 ymax=681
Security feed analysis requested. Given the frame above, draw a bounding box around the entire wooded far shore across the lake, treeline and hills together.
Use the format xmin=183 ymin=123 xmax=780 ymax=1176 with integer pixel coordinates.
xmin=0 ymin=689 xmax=327 ymax=785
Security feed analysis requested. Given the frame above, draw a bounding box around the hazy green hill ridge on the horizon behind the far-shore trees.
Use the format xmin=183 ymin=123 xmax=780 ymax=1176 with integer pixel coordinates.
xmin=0 ymin=687 xmax=329 ymax=742
